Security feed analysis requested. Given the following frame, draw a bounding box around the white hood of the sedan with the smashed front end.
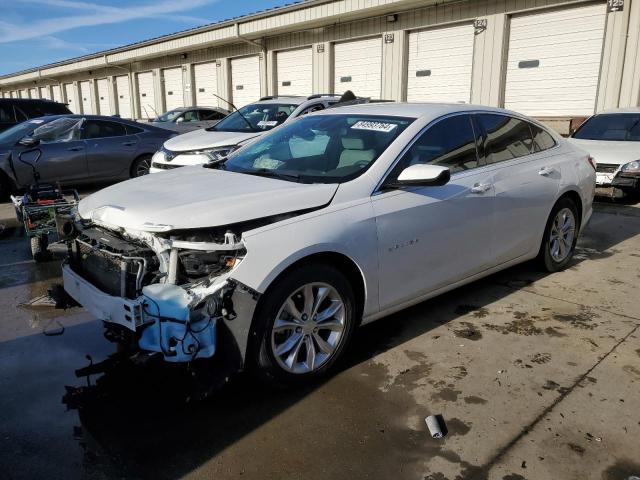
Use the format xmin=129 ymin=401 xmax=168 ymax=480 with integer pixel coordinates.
xmin=78 ymin=165 xmax=338 ymax=232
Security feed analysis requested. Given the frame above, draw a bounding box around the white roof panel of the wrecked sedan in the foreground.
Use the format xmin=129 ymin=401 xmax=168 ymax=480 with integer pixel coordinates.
xmin=315 ymin=102 xmax=522 ymax=118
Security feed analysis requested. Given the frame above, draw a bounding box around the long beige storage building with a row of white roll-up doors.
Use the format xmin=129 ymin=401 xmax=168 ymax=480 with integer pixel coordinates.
xmin=0 ymin=0 xmax=640 ymax=132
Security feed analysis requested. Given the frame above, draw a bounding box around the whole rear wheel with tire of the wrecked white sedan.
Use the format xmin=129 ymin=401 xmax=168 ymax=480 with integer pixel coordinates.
xmin=538 ymin=198 xmax=580 ymax=272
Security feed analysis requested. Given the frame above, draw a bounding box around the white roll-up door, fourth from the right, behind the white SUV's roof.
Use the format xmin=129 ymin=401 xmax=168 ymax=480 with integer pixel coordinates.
xmin=276 ymin=48 xmax=313 ymax=96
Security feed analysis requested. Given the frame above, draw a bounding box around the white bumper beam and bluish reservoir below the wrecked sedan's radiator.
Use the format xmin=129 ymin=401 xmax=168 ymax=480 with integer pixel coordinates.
xmin=62 ymin=262 xmax=260 ymax=372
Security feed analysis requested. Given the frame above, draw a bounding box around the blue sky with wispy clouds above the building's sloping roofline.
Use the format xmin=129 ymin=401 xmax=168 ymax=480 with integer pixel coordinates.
xmin=0 ymin=0 xmax=292 ymax=75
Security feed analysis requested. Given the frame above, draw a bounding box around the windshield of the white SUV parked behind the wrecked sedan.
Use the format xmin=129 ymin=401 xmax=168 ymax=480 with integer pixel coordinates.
xmin=207 ymin=103 xmax=298 ymax=132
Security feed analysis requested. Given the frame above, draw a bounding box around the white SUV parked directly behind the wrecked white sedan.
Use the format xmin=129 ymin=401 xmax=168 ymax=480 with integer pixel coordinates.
xmin=150 ymin=95 xmax=340 ymax=173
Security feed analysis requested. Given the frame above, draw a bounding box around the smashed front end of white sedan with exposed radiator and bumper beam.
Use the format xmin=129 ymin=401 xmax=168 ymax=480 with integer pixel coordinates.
xmin=63 ymin=219 xmax=259 ymax=370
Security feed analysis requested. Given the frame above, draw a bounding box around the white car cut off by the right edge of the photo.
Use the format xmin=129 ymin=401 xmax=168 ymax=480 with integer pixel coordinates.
xmin=570 ymin=108 xmax=640 ymax=198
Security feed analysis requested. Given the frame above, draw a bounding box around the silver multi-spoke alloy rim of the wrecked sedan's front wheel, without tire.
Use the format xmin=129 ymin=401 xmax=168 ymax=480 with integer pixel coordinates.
xmin=271 ymin=283 xmax=345 ymax=374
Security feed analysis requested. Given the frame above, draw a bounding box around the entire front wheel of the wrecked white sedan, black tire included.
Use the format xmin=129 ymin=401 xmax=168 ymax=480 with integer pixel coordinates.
xmin=254 ymin=264 xmax=356 ymax=385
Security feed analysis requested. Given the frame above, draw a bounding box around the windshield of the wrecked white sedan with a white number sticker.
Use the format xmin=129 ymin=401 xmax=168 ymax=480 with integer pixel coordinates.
xmin=221 ymin=114 xmax=413 ymax=183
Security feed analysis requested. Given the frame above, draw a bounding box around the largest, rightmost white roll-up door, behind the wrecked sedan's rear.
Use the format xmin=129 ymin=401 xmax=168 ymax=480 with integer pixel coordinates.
xmin=504 ymin=3 xmax=606 ymax=116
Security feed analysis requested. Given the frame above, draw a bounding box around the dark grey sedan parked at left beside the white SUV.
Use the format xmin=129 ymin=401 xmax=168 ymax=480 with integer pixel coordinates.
xmin=0 ymin=115 xmax=175 ymax=196
